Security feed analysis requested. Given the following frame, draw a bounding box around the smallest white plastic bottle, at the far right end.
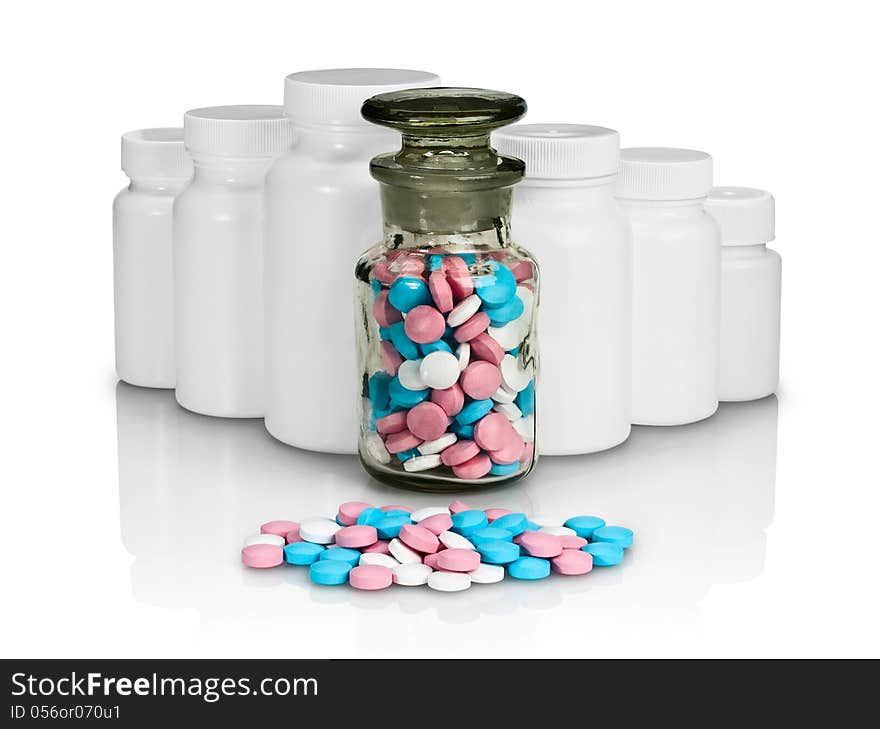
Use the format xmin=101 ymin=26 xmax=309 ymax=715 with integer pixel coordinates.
xmin=706 ymin=187 xmax=782 ymax=400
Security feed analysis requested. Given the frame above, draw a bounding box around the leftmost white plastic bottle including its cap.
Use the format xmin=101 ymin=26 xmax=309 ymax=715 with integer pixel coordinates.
xmin=113 ymin=128 xmax=193 ymax=388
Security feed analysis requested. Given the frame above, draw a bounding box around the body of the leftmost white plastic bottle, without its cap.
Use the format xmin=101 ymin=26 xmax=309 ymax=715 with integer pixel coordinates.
xmin=113 ymin=179 xmax=187 ymax=388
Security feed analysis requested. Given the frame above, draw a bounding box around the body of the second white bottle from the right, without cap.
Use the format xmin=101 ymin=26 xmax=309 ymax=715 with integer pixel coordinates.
xmin=620 ymin=199 xmax=721 ymax=425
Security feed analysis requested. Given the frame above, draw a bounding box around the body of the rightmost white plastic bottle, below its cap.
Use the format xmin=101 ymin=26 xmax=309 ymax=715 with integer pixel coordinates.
xmin=719 ymin=245 xmax=782 ymax=401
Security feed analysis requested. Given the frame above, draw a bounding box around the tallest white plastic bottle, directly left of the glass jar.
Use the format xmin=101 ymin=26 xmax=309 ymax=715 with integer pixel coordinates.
xmin=265 ymin=68 xmax=440 ymax=453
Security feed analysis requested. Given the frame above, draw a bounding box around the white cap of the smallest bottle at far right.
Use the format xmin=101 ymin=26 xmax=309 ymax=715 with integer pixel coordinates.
xmin=704 ymin=187 xmax=776 ymax=246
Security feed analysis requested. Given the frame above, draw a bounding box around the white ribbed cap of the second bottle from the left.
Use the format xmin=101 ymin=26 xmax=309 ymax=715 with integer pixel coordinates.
xmin=183 ymin=104 xmax=293 ymax=157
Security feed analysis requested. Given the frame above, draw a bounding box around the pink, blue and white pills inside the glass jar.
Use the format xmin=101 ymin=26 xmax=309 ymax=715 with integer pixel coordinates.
xmin=361 ymin=251 xmax=535 ymax=481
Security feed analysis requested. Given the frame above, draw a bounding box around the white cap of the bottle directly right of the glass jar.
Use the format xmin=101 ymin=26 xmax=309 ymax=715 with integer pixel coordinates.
xmin=492 ymin=124 xmax=620 ymax=180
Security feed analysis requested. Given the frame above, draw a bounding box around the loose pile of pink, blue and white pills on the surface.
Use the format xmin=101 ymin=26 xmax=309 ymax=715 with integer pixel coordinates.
xmin=241 ymin=501 xmax=633 ymax=592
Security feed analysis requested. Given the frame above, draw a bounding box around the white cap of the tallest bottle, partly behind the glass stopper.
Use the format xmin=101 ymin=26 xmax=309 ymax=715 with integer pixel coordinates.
xmin=284 ymin=68 xmax=440 ymax=128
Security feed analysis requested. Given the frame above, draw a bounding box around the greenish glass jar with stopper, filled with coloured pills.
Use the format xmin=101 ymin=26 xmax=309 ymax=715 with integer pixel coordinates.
xmin=355 ymin=88 xmax=538 ymax=491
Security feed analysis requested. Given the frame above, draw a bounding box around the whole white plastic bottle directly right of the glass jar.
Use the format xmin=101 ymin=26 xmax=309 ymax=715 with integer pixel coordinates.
xmin=492 ymin=124 xmax=632 ymax=456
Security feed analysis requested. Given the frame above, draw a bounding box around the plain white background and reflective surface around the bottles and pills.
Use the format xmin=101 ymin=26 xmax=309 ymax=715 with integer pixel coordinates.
xmin=0 ymin=0 xmax=880 ymax=657
